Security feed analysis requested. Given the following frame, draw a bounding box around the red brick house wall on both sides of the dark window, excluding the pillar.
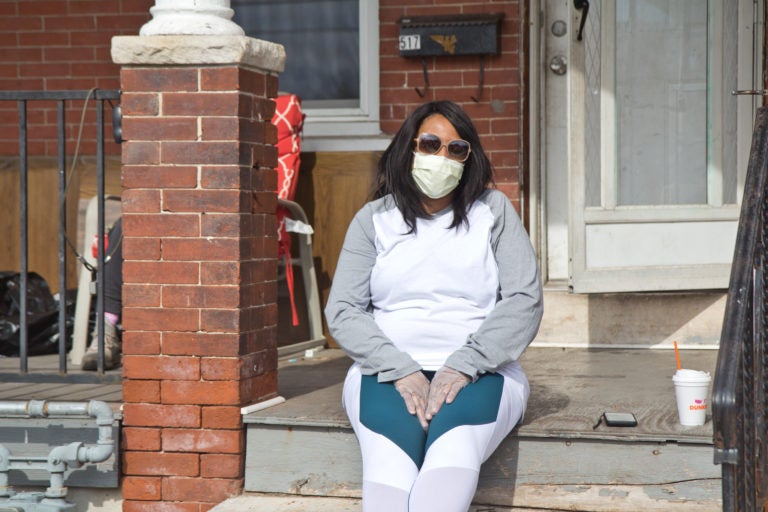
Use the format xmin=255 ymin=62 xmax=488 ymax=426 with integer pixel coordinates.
xmin=0 ymin=0 xmax=527 ymax=202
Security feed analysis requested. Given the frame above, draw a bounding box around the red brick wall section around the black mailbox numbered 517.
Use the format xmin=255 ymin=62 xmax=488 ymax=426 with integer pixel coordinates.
xmin=379 ymin=0 xmax=527 ymax=208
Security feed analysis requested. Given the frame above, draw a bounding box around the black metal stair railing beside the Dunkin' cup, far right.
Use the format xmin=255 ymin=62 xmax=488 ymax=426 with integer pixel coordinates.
xmin=712 ymin=107 xmax=768 ymax=512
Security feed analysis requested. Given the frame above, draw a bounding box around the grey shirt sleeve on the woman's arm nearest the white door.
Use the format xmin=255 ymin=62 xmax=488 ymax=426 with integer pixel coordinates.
xmin=445 ymin=190 xmax=543 ymax=379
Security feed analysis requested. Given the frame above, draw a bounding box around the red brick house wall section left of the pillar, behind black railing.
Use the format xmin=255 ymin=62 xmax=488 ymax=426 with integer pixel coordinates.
xmin=0 ymin=0 xmax=154 ymax=156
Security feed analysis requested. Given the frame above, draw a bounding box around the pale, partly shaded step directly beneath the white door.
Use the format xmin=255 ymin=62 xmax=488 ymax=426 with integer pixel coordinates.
xmin=533 ymin=283 xmax=727 ymax=348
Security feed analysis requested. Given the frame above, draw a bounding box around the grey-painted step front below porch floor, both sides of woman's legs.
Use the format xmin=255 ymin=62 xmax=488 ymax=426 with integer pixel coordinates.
xmin=245 ymin=424 xmax=721 ymax=511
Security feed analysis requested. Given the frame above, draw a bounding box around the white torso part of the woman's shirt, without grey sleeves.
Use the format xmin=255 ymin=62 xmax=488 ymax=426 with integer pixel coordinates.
xmin=370 ymin=202 xmax=499 ymax=370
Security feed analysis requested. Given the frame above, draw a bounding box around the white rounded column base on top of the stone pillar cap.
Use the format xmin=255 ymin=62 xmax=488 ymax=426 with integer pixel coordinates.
xmin=139 ymin=0 xmax=245 ymax=36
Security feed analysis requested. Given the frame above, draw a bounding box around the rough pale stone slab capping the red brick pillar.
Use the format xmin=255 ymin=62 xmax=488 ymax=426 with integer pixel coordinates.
xmin=112 ymin=35 xmax=285 ymax=73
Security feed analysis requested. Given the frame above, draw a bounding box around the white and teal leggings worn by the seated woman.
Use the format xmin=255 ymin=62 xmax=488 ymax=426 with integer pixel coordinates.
xmin=343 ymin=363 xmax=529 ymax=512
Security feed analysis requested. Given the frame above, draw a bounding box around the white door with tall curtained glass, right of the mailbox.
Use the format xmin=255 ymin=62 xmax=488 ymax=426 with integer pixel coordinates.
xmin=540 ymin=0 xmax=762 ymax=292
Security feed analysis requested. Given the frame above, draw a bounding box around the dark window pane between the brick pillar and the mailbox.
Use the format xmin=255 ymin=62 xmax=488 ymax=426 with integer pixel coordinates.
xmin=231 ymin=0 xmax=360 ymax=107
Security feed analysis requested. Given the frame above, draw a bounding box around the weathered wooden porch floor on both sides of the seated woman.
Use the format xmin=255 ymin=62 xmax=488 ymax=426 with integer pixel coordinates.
xmin=245 ymin=348 xmax=717 ymax=444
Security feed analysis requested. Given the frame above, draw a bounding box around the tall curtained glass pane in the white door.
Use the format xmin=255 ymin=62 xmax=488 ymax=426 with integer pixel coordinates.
xmin=616 ymin=0 xmax=707 ymax=205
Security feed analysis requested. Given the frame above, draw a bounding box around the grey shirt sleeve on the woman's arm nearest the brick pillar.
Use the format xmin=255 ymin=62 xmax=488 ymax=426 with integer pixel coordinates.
xmin=325 ymin=200 xmax=421 ymax=382
